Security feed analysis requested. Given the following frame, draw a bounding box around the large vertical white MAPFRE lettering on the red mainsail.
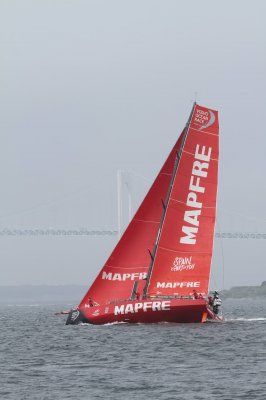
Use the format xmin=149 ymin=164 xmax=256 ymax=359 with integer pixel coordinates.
xmin=180 ymin=144 xmax=212 ymax=244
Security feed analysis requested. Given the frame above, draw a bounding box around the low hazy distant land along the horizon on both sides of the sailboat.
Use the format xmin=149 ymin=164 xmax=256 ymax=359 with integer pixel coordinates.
xmin=0 ymin=281 xmax=266 ymax=306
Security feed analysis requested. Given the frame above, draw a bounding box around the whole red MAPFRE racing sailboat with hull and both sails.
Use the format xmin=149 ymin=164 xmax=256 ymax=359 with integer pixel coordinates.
xmin=66 ymin=103 xmax=222 ymax=324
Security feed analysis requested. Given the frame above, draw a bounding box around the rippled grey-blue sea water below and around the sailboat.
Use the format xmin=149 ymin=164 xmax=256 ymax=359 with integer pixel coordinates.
xmin=0 ymin=298 xmax=266 ymax=400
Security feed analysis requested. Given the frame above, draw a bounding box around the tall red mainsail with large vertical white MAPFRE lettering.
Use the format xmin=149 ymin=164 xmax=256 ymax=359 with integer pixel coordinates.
xmin=147 ymin=105 xmax=219 ymax=296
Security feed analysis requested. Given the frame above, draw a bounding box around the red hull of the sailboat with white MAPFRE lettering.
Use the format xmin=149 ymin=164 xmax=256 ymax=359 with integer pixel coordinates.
xmin=67 ymin=298 xmax=221 ymax=325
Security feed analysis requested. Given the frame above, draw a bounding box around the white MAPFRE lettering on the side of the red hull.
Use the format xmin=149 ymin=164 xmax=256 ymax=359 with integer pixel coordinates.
xmin=114 ymin=300 xmax=171 ymax=315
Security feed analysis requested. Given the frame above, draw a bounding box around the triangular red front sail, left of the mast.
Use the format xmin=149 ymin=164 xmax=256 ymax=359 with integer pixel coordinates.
xmin=79 ymin=133 xmax=183 ymax=308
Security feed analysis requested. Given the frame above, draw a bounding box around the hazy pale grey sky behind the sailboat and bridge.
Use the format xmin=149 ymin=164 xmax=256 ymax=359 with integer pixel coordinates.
xmin=0 ymin=0 xmax=266 ymax=287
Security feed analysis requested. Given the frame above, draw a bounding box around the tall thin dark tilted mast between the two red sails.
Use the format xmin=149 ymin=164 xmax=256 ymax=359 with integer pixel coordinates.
xmin=143 ymin=102 xmax=196 ymax=298
